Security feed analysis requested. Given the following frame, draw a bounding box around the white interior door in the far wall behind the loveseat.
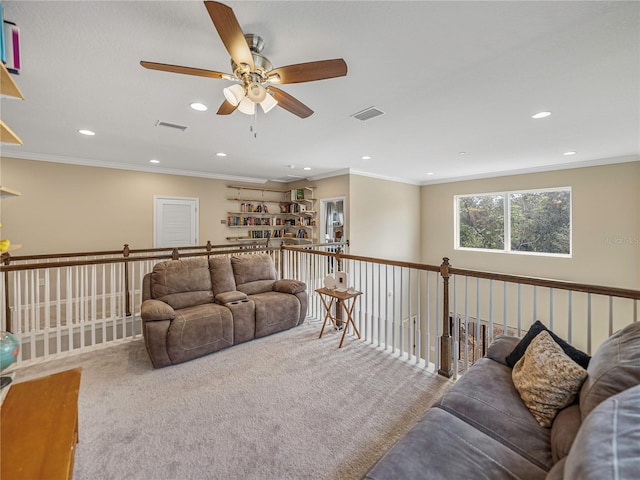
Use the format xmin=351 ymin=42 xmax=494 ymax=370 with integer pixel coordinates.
xmin=153 ymin=195 xmax=198 ymax=248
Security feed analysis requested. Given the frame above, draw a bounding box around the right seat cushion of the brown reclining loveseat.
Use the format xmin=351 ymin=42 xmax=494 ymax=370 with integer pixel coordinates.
xmin=249 ymin=292 xmax=300 ymax=338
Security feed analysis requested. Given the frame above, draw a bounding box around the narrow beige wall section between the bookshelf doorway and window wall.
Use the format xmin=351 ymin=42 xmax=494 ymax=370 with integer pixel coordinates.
xmin=349 ymin=175 xmax=420 ymax=262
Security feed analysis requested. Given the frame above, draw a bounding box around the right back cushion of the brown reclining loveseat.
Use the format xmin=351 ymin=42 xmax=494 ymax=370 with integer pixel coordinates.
xmin=231 ymin=253 xmax=277 ymax=295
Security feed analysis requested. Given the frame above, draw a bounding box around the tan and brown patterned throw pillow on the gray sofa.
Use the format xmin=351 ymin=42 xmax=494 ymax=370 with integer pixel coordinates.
xmin=511 ymin=331 xmax=587 ymax=428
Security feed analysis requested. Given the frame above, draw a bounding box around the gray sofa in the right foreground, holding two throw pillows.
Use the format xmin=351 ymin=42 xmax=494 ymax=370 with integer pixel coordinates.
xmin=366 ymin=322 xmax=640 ymax=480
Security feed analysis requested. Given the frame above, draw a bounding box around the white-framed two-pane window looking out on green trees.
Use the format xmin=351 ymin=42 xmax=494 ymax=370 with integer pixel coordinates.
xmin=455 ymin=187 xmax=571 ymax=256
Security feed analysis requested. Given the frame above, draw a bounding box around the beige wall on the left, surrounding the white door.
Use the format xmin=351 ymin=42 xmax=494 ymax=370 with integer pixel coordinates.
xmin=0 ymin=158 xmax=258 ymax=255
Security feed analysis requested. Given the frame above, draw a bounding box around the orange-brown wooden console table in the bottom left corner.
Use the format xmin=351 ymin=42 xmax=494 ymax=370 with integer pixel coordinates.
xmin=0 ymin=368 xmax=82 ymax=480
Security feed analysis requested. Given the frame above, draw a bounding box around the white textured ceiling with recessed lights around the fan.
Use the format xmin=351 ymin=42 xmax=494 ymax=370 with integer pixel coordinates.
xmin=2 ymin=0 xmax=640 ymax=184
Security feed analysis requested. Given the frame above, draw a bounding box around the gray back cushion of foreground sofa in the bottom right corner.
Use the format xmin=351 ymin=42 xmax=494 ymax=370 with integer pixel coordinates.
xmin=564 ymin=386 xmax=640 ymax=480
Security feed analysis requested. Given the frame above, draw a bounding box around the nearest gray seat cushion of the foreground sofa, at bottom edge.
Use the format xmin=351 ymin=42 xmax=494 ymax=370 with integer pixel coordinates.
xmin=366 ymin=408 xmax=547 ymax=480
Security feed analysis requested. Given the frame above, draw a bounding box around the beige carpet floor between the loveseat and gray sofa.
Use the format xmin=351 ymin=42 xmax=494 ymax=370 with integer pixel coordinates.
xmin=16 ymin=320 xmax=451 ymax=480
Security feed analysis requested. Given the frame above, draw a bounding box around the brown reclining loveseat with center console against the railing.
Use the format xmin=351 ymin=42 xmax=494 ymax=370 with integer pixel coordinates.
xmin=141 ymin=254 xmax=307 ymax=368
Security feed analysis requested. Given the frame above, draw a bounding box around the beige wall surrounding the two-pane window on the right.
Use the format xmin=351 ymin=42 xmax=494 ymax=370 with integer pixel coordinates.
xmin=421 ymin=162 xmax=640 ymax=289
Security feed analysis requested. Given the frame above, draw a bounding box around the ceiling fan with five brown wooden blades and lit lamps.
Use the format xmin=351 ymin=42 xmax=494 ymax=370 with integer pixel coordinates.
xmin=140 ymin=1 xmax=347 ymax=118
